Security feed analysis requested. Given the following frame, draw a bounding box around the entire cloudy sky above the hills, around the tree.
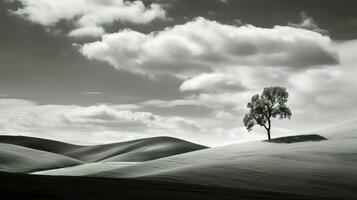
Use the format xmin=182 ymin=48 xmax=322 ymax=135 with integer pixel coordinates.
xmin=0 ymin=0 xmax=357 ymax=146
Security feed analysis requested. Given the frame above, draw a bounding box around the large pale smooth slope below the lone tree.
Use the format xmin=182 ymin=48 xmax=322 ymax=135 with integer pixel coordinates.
xmin=69 ymin=122 xmax=357 ymax=199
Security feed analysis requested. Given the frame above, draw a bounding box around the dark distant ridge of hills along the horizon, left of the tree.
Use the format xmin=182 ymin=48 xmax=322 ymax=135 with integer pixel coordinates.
xmin=0 ymin=136 xmax=207 ymax=162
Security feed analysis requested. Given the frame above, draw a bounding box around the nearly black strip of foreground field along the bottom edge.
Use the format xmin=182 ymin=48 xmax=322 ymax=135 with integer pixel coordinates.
xmin=0 ymin=173 xmax=342 ymax=200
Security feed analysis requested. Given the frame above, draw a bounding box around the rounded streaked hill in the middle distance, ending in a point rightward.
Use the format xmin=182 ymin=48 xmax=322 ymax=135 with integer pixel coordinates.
xmin=66 ymin=137 xmax=207 ymax=162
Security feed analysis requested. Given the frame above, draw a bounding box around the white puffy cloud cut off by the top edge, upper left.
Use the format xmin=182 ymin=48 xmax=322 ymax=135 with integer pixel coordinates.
xmin=6 ymin=0 xmax=166 ymax=37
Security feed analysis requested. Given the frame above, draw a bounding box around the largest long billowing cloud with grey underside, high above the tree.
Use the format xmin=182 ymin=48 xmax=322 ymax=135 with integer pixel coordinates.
xmin=80 ymin=17 xmax=338 ymax=78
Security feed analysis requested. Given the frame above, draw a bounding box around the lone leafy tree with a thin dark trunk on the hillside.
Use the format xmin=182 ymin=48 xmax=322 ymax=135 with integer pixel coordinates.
xmin=243 ymin=86 xmax=291 ymax=140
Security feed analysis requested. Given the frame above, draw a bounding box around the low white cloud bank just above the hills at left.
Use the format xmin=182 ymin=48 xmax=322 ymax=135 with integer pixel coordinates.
xmin=0 ymin=99 xmax=201 ymax=144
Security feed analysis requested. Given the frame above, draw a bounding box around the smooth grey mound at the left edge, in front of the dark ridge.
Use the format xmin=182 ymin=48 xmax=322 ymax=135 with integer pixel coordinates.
xmin=0 ymin=143 xmax=82 ymax=173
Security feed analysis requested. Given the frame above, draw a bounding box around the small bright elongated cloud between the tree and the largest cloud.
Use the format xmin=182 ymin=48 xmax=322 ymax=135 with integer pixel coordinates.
xmin=180 ymin=66 xmax=290 ymax=93
